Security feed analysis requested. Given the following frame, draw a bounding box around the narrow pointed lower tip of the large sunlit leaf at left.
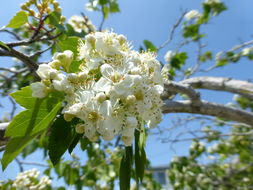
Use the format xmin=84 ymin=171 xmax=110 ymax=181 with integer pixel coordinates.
xmin=1 ymin=133 xmax=40 ymax=170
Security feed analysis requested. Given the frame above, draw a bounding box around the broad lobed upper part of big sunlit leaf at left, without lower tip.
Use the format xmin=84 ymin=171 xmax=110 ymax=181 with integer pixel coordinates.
xmin=5 ymin=87 xmax=63 ymax=137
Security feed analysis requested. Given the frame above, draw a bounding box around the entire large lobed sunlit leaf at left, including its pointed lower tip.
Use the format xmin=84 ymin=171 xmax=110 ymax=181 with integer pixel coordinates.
xmin=1 ymin=87 xmax=62 ymax=169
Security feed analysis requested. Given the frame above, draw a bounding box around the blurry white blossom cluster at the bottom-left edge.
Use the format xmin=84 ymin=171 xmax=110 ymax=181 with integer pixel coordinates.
xmin=13 ymin=169 xmax=52 ymax=190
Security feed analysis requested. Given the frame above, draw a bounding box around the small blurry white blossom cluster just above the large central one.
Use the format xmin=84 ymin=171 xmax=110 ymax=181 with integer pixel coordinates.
xmin=68 ymin=15 xmax=96 ymax=33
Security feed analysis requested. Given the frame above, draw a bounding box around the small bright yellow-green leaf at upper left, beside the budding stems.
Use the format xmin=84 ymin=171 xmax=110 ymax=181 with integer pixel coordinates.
xmin=6 ymin=11 xmax=28 ymax=28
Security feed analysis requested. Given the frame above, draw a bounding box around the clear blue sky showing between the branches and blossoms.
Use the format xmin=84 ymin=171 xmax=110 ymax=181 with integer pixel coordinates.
xmin=0 ymin=0 xmax=253 ymax=184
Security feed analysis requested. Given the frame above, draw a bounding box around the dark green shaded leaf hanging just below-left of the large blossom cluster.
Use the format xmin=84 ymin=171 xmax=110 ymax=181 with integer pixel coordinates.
xmin=48 ymin=115 xmax=75 ymax=165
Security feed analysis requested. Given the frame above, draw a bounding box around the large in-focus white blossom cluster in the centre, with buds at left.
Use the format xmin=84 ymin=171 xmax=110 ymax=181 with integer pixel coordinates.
xmin=32 ymin=31 xmax=163 ymax=146
